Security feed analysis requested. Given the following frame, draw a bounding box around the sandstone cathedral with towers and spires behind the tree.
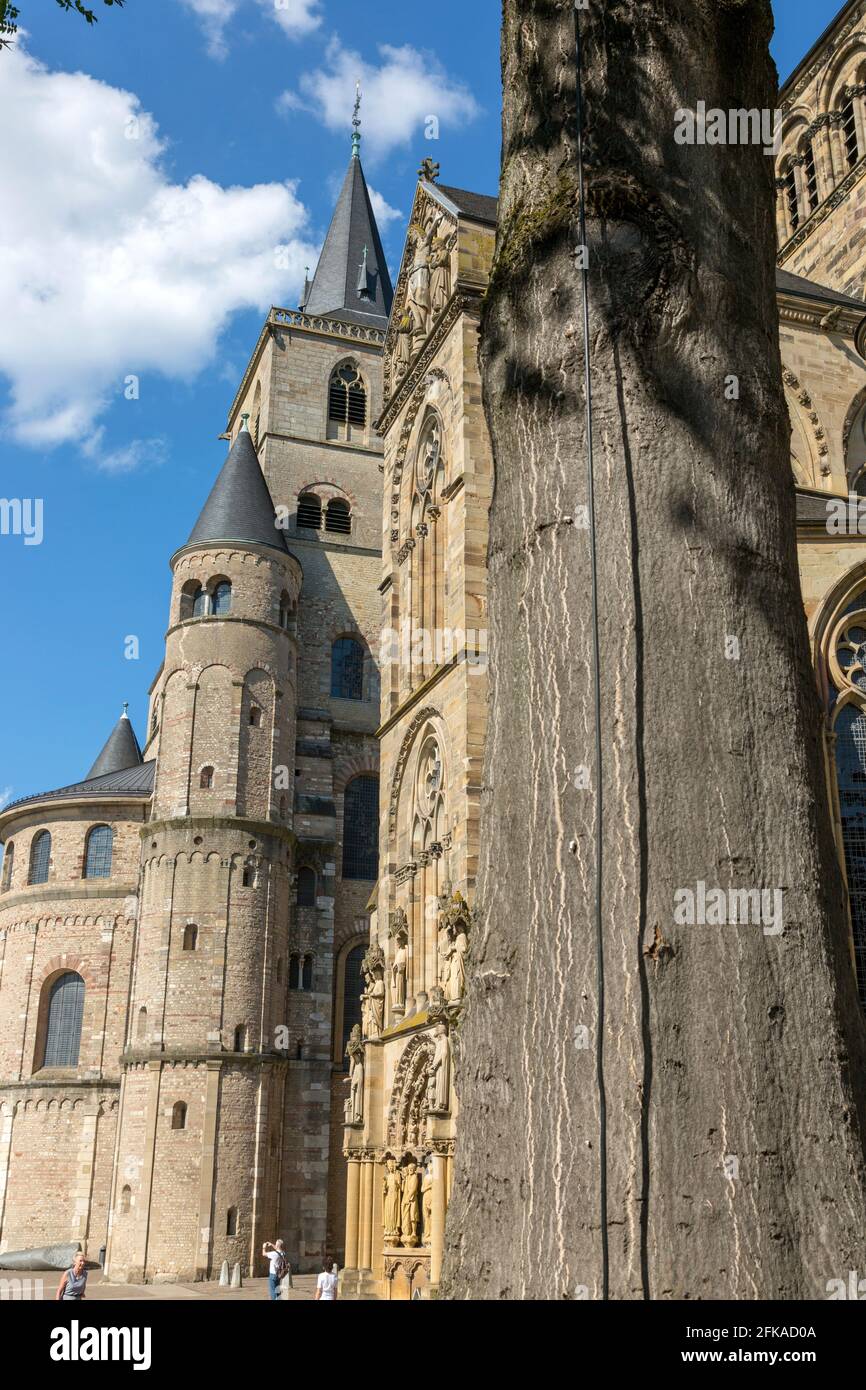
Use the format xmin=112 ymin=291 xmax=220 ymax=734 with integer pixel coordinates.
xmin=0 ymin=0 xmax=866 ymax=1300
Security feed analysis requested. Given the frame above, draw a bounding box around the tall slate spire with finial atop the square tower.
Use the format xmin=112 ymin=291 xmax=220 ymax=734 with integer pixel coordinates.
xmin=303 ymin=85 xmax=393 ymax=328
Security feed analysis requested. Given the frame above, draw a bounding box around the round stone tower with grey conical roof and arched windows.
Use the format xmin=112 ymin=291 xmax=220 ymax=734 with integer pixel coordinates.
xmin=107 ymin=421 xmax=302 ymax=1282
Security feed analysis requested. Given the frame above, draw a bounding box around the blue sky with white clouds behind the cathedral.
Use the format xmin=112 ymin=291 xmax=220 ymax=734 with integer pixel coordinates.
xmin=0 ymin=0 xmax=856 ymax=803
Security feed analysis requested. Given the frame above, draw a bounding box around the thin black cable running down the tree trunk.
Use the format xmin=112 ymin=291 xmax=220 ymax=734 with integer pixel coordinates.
xmin=574 ymin=0 xmax=610 ymax=1300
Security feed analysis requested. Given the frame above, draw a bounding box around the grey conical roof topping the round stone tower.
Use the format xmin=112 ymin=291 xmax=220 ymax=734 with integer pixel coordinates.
xmin=186 ymin=428 xmax=286 ymax=550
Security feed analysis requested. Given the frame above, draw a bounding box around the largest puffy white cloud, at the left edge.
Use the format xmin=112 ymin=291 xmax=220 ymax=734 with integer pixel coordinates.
xmin=0 ymin=47 xmax=316 ymax=447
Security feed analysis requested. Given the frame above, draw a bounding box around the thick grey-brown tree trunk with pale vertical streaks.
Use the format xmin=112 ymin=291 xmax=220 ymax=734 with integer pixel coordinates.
xmin=442 ymin=0 xmax=866 ymax=1298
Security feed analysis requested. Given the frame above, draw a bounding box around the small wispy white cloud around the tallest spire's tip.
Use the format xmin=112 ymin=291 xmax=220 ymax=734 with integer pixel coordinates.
xmin=277 ymin=39 xmax=481 ymax=160
